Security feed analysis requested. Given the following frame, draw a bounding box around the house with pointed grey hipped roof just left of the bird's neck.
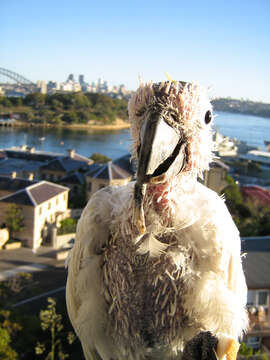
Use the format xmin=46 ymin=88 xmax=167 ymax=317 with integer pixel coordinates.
xmin=85 ymin=161 xmax=133 ymax=199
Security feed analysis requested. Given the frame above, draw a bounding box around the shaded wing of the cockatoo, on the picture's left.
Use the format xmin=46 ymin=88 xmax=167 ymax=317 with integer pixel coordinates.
xmin=66 ymin=187 xmax=118 ymax=360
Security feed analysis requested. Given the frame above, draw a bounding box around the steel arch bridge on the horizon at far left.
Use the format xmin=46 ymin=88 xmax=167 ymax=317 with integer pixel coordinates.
xmin=0 ymin=67 xmax=37 ymax=94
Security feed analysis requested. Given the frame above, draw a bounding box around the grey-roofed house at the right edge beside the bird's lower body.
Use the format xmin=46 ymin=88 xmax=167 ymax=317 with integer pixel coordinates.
xmin=241 ymin=236 xmax=270 ymax=352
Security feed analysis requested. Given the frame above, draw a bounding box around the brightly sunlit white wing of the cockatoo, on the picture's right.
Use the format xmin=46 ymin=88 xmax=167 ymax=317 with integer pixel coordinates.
xmin=182 ymin=185 xmax=248 ymax=339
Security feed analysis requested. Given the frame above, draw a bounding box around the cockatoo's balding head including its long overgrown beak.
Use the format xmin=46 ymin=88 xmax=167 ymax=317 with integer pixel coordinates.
xmin=128 ymin=81 xmax=213 ymax=233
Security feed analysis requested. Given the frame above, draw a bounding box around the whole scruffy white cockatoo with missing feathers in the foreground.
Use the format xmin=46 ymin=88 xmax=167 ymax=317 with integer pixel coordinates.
xmin=66 ymin=81 xmax=248 ymax=360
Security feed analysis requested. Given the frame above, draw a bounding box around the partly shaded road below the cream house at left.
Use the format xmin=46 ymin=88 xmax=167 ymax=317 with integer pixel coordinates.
xmin=0 ymin=247 xmax=67 ymax=313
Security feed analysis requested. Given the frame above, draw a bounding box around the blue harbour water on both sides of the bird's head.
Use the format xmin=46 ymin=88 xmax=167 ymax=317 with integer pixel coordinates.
xmin=0 ymin=113 xmax=270 ymax=159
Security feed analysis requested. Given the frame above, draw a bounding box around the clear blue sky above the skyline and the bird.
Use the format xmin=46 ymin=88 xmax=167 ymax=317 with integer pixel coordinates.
xmin=0 ymin=0 xmax=270 ymax=102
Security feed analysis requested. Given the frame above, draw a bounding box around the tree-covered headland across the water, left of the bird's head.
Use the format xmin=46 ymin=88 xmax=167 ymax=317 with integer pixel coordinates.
xmin=0 ymin=93 xmax=128 ymax=125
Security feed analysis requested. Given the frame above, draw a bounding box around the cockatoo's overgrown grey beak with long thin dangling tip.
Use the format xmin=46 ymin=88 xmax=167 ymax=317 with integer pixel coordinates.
xmin=134 ymin=113 xmax=186 ymax=234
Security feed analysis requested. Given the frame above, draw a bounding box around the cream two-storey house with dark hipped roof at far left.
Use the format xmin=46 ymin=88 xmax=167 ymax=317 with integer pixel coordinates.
xmin=0 ymin=178 xmax=69 ymax=249
